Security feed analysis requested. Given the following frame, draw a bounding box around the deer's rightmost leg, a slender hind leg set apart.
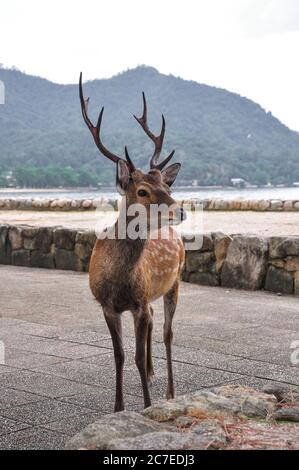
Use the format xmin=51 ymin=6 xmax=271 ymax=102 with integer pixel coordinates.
xmin=163 ymin=281 xmax=179 ymax=400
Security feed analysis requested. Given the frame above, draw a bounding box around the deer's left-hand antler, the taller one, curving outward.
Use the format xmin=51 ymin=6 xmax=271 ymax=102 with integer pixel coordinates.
xmin=79 ymin=72 xmax=135 ymax=172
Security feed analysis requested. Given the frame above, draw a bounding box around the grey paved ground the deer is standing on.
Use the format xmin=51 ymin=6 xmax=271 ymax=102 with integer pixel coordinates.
xmin=0 ymin=266 xmax=299 ymax=449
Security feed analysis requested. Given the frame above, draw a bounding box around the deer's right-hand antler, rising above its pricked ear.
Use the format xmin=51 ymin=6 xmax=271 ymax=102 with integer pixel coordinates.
xmin=134 ymin=92 xmax=175 ymax=170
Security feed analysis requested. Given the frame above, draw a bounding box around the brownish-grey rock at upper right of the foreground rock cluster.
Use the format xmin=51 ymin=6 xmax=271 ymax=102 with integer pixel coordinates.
xmin=213 ymin=385 xmax=277 ymax=418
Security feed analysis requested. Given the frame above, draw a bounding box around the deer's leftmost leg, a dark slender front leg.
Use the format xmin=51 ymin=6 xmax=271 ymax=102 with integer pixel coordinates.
xmin=104 ymin=309 xmax=125 ymax=412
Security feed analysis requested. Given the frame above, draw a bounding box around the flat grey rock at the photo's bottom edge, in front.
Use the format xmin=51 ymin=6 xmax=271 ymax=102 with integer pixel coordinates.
xmin=107 ymin=431 xmax=223 ymax=451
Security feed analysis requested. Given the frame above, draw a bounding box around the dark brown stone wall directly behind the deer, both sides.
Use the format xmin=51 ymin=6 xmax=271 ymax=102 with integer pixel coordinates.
xmin=0 ymin=225 xmax=299 ymax=295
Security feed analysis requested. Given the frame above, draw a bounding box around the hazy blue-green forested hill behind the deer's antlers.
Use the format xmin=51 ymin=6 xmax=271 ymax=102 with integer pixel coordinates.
xmin=0 ymin=65 xmax=299 ymax=186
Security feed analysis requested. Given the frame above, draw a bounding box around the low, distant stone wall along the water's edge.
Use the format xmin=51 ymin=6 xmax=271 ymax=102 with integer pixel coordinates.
xmin=0 ymin=198 xmax=299 ymax=212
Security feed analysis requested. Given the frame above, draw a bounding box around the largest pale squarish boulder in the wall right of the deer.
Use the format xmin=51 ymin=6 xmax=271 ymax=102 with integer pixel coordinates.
xmin=221 ymin=235 xmax=268 ymax=290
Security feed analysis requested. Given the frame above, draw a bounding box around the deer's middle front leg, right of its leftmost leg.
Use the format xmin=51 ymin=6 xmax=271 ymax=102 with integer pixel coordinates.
xmin=133 ymin=307 xmax=152 ymax=408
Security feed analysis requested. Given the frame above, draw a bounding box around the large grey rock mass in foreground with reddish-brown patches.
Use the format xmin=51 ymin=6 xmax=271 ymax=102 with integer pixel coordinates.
xmin=66 ymin=384 xmax=299 ymax=450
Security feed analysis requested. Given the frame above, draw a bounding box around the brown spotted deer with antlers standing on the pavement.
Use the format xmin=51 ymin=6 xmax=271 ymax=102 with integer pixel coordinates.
xmin=79 ymin=73 xmax=186 ymax=412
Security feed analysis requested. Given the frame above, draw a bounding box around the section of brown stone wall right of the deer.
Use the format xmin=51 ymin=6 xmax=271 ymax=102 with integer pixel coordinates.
xmin=183 ymin=233 xmax=299 ymax=295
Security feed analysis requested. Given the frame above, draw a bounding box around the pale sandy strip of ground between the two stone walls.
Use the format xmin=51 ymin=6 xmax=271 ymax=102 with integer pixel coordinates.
xmin=0 ymin=211 xmax=299 ymax=236
